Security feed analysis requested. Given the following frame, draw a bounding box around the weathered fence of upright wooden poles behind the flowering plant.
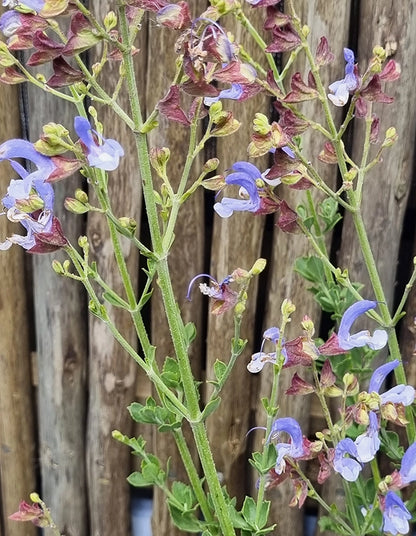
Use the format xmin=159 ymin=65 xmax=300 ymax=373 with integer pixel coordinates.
xmin=0 ymin=0 xmax=416 ymax=536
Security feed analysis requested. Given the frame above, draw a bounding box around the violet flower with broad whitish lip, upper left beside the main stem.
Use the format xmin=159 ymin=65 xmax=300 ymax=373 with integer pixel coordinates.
xmin=74 ymin=116 xmax=124 ymax=171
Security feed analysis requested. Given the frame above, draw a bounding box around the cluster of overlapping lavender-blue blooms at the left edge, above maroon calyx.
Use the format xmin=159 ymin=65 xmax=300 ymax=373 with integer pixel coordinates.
xmin=0 ymin=139 xmax=55 ymax=250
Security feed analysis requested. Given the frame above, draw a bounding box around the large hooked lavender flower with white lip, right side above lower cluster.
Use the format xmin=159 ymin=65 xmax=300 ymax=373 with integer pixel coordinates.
xmin=338 ymin=300 xmax=388 ymax=350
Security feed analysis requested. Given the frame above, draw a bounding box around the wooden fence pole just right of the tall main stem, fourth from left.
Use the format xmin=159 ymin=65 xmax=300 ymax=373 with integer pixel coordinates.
xmin=146 ymin=1 xmax=205 ymax=536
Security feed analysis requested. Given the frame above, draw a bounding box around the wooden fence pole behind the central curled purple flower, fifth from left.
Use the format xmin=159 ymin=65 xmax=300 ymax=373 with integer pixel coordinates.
xmin=206 ymin=5 xmax=270 ymax=502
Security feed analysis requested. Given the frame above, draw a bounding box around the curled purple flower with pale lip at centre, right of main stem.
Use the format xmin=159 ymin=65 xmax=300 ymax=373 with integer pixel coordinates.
xmin=214 ymin=162 xmax=262 ymax=218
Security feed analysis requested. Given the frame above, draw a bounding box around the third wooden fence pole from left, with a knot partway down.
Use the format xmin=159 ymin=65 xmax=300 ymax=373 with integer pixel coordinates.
xmin=87 ymin=4 xmax=143 ymax=536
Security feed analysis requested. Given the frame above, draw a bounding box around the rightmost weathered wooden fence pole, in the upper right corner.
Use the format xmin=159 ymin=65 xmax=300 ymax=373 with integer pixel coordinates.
xmin=339 ymin=0 xmax=416 ymax=305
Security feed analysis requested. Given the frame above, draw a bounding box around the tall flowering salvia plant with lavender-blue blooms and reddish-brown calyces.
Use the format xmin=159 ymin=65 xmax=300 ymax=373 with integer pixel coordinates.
xmin=0 ymin=0 xmax=416 ymax=536
